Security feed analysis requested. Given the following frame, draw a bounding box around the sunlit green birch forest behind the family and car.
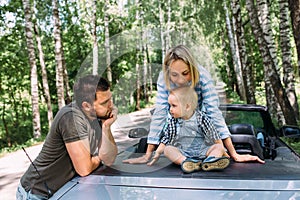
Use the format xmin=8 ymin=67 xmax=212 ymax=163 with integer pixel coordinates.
xmin=0 ymin=0 xmax=300 ymax=152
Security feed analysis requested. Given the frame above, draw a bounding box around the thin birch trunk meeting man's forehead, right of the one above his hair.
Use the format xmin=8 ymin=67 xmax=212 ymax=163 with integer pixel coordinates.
xmin=104 ymin=0 xmax=112 ymax=83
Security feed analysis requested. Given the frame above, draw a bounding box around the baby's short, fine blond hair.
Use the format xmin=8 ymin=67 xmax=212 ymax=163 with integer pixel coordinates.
xmin=170 ymin=86 xmax=198 ymax=110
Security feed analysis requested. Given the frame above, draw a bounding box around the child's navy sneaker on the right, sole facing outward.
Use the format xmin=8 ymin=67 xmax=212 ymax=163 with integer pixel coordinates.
xmin=202 ymin=156 xmax=230 ymax=171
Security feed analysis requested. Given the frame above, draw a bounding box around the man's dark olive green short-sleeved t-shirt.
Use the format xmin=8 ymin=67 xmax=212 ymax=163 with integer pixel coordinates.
xmin=21 ymin=102 xmax=102 ymax=196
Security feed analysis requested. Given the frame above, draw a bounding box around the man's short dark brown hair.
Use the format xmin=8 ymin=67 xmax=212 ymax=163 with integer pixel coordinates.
xmin=73 ymin=75 xmax=110 ymax=107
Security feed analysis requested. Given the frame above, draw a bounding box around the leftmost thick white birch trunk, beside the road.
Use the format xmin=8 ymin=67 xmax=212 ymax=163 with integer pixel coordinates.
xmin=23 ymin=0 xmax=41 ymax=138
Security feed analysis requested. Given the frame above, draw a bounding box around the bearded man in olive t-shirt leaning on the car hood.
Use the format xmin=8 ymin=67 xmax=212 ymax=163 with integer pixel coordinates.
xmin=16 ymin=75 xmax=118 ymax=199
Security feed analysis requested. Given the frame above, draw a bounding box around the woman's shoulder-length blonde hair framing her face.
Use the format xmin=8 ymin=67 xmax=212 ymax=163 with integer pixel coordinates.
xmin=163 ymin=45 xmax=200 ymax=89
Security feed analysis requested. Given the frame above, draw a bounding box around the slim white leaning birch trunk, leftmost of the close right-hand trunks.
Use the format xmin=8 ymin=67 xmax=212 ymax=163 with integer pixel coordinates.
xmin=224 ymin=1 xmax=246 ymax=100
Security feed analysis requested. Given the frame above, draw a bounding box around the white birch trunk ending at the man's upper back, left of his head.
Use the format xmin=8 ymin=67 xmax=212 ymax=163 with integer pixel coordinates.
xmin=52 ymin=0 xmax=65 ymax=109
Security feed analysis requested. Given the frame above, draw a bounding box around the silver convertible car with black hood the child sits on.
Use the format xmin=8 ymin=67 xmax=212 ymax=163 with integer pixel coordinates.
xmin=51 ymin=104 xmax=300 ymax=200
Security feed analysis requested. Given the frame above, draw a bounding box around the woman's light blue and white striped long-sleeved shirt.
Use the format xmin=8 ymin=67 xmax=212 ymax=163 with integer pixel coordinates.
xmin=148 ymin=66 xmax=230 ymax=145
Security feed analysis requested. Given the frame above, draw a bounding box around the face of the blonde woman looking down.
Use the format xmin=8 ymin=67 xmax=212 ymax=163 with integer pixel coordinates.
xmin=169 ymin=60 xmax=192 ymax=87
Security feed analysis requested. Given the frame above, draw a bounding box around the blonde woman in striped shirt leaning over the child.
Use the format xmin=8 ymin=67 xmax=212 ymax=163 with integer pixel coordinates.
xmin=123 ymin=45 xmax=264 ymax=164
